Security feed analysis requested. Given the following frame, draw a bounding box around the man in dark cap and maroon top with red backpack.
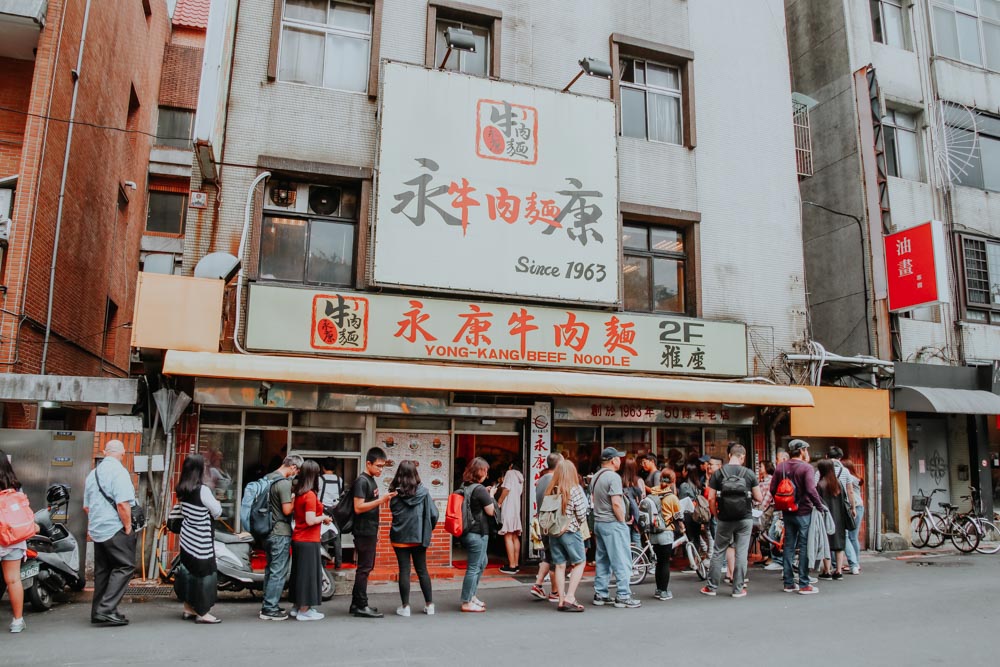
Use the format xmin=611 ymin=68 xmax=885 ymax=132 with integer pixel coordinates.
xmin=770 ymin=439 xmax=828 ymax=595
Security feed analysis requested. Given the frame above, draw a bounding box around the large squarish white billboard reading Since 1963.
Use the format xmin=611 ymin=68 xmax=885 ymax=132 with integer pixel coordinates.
xmin=373 ymin=63 xmax=619 ymax=304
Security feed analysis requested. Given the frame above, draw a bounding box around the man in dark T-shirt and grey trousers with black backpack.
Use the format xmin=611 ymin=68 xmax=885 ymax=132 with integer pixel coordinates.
xmin=701 ymin=445 xmax=763 ymax=598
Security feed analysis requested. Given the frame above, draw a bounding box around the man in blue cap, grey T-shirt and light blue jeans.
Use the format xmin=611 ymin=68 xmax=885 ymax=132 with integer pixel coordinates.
xmin=590 ymin=447 xmax=642 ymax=609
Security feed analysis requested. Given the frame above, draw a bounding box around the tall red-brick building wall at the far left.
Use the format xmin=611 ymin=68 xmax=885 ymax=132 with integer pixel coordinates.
xmin=0 ymin=0 xmax=169 ymax=386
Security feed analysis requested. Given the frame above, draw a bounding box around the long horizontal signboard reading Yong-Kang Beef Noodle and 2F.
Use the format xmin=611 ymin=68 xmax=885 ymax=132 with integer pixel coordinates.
xmin=247 ymin=285 xmax=747 ymax=377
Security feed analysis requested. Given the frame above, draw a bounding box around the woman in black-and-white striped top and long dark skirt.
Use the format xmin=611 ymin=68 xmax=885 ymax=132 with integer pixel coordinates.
xmin=174 ymin=454 xmax=222 ymax=623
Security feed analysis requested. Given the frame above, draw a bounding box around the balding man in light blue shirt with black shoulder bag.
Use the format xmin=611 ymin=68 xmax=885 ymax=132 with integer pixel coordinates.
xmin=83 ymin=440 xmax=136 ymax=626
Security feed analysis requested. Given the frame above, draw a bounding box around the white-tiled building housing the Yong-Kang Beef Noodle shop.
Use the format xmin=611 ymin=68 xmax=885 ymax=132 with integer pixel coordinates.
xmin=133 ymin=0 xmax=828 ymax=573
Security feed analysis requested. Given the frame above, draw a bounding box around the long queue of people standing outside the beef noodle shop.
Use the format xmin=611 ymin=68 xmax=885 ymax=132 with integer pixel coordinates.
xmin=0 ymin=439 xmax=864 ymax=632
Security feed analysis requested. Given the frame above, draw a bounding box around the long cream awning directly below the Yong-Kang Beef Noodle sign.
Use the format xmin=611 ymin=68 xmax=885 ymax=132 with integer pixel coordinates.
xmin=163 ymin=350 xmax=813 ymax=406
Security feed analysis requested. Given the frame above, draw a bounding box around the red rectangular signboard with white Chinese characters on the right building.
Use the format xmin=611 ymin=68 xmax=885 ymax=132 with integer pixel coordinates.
xmin=885 ymin=221 xmax=947 ymax=311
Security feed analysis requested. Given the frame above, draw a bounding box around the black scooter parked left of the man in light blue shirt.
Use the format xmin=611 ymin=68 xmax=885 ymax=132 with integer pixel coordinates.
xmin=21 ymin=484 xmax=86 ymax=611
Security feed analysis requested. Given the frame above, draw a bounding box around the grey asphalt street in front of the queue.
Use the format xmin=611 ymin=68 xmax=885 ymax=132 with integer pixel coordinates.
xmin=0 ymin=554 xmax=1000 ymax=667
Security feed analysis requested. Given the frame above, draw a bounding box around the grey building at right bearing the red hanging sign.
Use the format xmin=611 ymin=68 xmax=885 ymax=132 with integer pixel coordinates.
xmin=785 ymin=0 xmax=1000 ymax=532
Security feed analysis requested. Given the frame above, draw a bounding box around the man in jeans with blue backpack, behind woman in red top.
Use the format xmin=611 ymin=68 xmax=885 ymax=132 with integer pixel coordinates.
xmin=253 ymin=454 xmax=302 ymax=621
